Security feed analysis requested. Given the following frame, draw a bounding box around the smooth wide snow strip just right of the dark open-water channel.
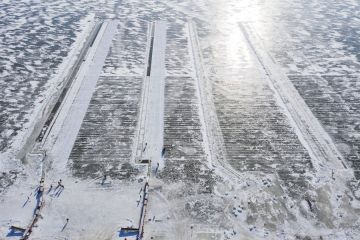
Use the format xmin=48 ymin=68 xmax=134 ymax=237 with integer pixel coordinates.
xmin=45 ymin=21 xmax=117 ymax=171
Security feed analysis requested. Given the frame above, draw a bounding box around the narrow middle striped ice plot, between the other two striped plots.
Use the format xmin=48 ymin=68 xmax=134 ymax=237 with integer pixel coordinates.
xmin=161 ymin=23 xmax=213 ymax=188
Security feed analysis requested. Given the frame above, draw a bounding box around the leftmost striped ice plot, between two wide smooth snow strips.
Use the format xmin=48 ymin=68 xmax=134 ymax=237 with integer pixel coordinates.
xmin=70 ymin=20 xmax=148 ymax=179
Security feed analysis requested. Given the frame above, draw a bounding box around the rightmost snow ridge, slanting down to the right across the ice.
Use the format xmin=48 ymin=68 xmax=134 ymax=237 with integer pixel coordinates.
xmin=240 ymin=24 xmax=351 ymax=176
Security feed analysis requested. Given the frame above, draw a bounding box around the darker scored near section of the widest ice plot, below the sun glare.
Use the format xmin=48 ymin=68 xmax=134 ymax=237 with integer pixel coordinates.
xmin=214 ymin=74 xmax=311 ymax=192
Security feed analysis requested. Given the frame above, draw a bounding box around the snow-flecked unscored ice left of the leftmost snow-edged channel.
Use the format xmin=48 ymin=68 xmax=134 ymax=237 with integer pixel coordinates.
xmin=0 ymin=1 xmax=92 ymax=158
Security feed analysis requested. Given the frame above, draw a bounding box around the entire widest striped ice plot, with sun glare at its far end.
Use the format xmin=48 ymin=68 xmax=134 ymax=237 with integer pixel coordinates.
xmin=203 ymin=26 xmax=312 ymax=194
